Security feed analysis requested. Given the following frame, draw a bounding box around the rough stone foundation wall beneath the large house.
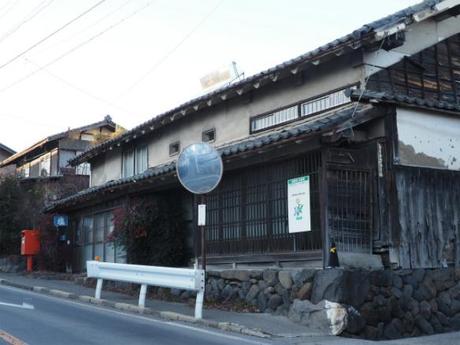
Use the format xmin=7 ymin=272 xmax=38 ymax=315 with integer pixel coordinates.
xmin=206 ymin=268 xmax=460 ymax=339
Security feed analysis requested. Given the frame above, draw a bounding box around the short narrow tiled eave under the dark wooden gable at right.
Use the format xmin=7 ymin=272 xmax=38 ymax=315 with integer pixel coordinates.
xmin=350 ymin=90 xmax=460 ymax=111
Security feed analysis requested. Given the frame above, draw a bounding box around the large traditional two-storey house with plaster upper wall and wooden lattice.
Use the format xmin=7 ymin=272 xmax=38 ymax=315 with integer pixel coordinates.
xmin=47 ymin=0 xmax=460 ymax=268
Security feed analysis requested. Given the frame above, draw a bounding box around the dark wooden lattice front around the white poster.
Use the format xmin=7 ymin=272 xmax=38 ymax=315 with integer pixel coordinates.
xmin=203 ymin=153 xmax=322 ymax=256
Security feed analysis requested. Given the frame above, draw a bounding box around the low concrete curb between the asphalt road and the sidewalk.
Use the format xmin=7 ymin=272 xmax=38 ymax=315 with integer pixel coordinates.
xmin=0 ymin=279 xmax=271 ymax=338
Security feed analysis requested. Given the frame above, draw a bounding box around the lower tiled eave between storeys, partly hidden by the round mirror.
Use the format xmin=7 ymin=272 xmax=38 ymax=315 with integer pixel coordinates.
xmin=45 ymin=103 xmax=372 ymax=212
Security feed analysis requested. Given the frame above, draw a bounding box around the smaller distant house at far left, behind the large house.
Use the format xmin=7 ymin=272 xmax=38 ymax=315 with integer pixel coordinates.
xmin=0 ymin=116 xmax=122 ymax=200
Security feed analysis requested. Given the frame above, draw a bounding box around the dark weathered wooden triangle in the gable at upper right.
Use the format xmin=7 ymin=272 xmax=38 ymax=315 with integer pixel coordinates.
xmin=367 ymin=34 xmax=460 ymax=104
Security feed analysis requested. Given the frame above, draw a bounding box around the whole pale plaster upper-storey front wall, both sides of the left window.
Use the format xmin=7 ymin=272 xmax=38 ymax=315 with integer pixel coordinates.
xmin=91 ymin=60 xmax=363 ymax=186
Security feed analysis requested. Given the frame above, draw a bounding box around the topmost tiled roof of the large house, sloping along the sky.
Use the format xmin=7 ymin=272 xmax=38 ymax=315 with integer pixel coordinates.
xmin=69 ymin=0 xmax=459 ymax=165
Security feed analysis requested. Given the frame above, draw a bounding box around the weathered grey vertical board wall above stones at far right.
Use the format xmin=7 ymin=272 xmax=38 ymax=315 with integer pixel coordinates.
xmin=395 ymin=166 xmax=460 ymax=268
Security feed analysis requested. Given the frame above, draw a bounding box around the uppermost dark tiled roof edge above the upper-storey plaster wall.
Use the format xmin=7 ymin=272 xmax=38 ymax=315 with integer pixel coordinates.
xmin=69 ymin=0 xmax=441 ymax=165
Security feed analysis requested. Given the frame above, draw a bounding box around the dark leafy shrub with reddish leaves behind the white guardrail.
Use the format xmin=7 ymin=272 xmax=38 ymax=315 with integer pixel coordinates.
xmin=112 ymin=194 xmax=189 ymax=267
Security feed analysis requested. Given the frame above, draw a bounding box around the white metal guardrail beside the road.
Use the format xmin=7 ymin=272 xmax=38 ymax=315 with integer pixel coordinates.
xmin=86 ymin=261 xmax=205 ymax=319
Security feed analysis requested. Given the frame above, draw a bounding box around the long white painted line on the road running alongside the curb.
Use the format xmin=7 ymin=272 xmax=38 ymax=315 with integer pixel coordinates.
xmin=0 ymin=286 xmax=270 ymax=345
